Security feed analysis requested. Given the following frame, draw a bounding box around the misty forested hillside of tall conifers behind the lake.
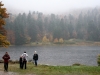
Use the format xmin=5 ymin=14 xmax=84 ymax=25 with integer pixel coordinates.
xmin=5 ymin=8 xmax=100 ymax=45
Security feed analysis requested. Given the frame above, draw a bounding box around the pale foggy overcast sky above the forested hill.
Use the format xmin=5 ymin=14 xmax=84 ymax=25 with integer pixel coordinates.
xmin=1 ymin=0 xmax=100 ymax=13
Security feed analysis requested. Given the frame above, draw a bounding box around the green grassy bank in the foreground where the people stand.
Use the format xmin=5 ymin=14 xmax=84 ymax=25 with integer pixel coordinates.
xmin=0 ymin=63 xmax=100 ymax=75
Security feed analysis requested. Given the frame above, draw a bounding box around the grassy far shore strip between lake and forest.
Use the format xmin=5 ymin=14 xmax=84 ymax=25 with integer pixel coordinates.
xmin=16 ymin=40 xmax=100 ymax=46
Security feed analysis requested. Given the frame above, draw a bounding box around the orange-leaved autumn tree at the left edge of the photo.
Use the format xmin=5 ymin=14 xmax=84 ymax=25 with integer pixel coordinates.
xmin=0 ymin=2 xmax=10 ymax=47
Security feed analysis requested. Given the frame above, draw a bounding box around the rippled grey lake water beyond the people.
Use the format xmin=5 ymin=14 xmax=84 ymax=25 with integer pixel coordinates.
xmin=0 ymin=46 xmax=100 ymax=66
